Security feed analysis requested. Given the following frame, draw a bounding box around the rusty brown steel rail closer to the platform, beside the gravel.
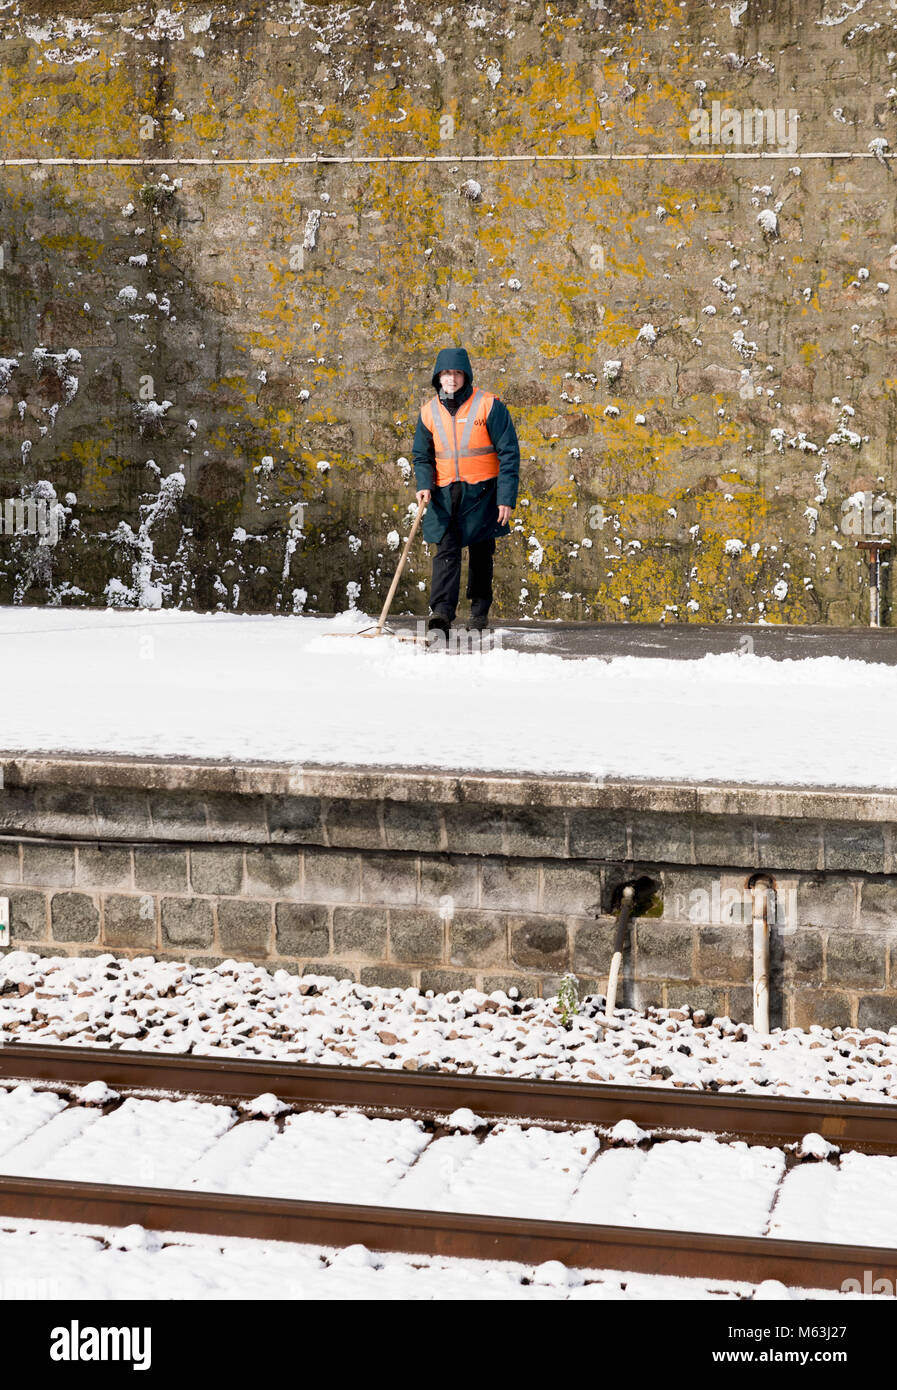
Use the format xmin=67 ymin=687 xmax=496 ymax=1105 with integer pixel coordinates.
xmin=0 ymin=1043 xmax=897 ymax=1155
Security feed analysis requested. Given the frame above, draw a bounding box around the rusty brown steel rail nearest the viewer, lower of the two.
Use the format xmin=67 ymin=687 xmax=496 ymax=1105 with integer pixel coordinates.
xmin=0 ymin=1177 xmax=897 ymax=1289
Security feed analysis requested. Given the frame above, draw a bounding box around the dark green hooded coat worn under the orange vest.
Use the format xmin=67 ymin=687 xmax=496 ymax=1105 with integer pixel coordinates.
xmin=413 ymin=348 xmax=520 ymax=545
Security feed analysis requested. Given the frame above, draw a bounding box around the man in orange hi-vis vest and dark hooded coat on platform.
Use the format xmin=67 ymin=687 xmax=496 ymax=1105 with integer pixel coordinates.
xmin=413 ymin=348 xmax=520 ymax=639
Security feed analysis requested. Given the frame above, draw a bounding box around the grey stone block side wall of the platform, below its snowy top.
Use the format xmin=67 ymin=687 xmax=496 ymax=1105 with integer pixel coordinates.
xmin=0 ymin=758 xmax=897 ymax=1027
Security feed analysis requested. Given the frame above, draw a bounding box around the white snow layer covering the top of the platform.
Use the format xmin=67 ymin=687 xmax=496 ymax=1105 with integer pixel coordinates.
xmin=0 ymin=607 xmax=897 ymax=788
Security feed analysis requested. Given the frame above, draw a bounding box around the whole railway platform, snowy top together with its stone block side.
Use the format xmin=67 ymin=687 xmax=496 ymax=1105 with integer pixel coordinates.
xmin=0 ymin=609 xmax=897 ymax=1029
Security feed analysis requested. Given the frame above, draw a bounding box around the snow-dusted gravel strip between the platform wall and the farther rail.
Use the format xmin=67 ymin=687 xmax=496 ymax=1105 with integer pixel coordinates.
xmin=0 ymin=951 xmax=897 ymax=1101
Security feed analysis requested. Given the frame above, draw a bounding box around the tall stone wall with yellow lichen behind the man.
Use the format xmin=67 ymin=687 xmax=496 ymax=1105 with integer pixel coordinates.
xmin=0 ymin=0 xmax=897 ymax=626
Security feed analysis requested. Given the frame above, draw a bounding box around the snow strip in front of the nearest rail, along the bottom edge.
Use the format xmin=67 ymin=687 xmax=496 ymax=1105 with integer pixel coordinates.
xmin=0 ymin=1216 xmax=834 ymax=1302
